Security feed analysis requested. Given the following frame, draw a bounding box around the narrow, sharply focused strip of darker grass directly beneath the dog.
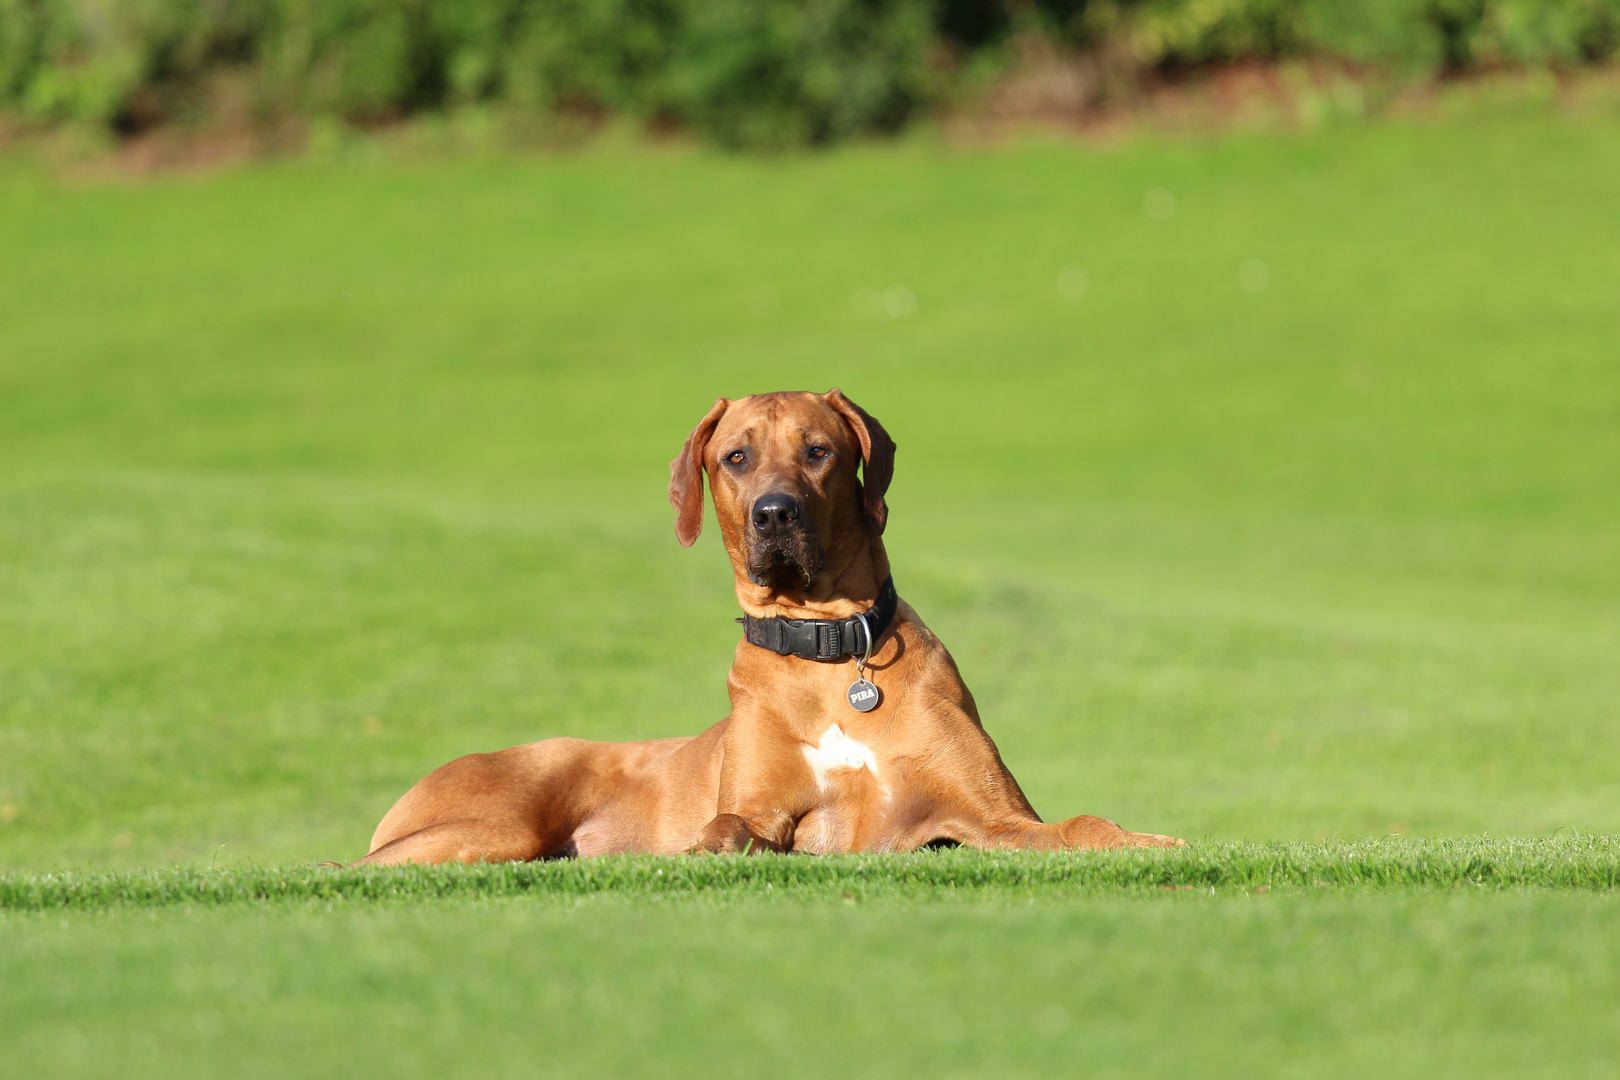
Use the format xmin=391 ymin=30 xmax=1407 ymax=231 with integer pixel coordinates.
xmin=9 ymin=837 xmax=1620 ymax=912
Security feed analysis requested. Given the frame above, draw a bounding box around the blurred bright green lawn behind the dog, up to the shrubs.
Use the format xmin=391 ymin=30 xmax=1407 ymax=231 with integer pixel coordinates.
xmin=0 ymin=110 xmax=1620 ymax=870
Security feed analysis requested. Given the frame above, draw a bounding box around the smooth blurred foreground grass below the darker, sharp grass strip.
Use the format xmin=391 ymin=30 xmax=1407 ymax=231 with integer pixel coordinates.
xmin=12 ymin=892 xmax=1620 ymax=1078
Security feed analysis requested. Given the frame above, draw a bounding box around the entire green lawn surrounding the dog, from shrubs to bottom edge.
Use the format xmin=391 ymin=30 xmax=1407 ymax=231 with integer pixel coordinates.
xmin=0 ymin=112 xmax=1620 ymax=1077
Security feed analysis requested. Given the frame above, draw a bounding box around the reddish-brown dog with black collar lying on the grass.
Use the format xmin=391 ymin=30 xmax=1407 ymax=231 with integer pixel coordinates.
xmin=361 ymin=390 xmax=1179 ymax=863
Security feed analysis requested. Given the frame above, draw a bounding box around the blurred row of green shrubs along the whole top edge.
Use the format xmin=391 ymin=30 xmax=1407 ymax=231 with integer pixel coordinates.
xmin=0 ymin=0 xmax=1620 ymax=144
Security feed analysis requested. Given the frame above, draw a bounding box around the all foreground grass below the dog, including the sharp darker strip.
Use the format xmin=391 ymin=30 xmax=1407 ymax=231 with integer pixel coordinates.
xmin=9 ymin=839 xmax=1620 ymax=1077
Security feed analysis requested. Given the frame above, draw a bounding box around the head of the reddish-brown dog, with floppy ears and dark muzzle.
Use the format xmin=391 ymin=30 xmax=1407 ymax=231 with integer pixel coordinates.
xmin=669 ymin=390 xmax=894 ymax=594
